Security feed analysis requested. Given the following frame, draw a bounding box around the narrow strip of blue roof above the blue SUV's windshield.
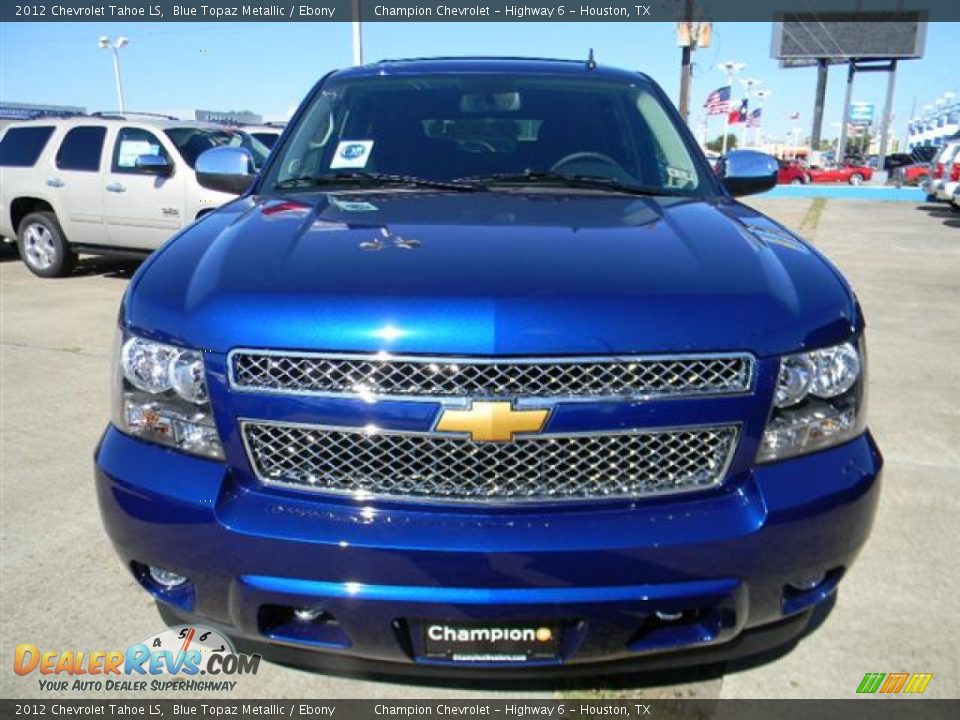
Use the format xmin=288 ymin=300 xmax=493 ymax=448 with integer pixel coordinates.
xmin=336 ymin=57 xmax=648 ymax=82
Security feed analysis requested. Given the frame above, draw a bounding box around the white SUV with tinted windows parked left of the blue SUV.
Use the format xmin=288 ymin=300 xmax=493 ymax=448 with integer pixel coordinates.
xmin=0 ymin=115 xmax=268 ymax=277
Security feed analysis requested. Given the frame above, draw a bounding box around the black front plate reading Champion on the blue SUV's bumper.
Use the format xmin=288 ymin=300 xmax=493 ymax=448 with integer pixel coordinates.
xmin=421 ymin=622 xmax=562 ymax=662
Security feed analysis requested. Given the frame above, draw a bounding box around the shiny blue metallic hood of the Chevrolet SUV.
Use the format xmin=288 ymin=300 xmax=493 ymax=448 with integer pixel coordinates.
xmin=123 ymin=191 xmax=860 ymax=356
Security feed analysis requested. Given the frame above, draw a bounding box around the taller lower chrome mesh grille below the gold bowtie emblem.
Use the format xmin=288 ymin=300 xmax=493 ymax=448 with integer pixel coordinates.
xmin=243 ymin=421 xmax=738 ymax=502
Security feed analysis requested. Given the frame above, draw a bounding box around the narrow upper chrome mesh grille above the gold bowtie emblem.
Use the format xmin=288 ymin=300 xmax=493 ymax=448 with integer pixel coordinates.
xmin=230 ymin=351 xmax=753 ymax=399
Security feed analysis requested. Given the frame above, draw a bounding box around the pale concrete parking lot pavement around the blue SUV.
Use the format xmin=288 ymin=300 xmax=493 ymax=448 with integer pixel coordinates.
xmin=0 ymin=197 xmax=960 ymax=699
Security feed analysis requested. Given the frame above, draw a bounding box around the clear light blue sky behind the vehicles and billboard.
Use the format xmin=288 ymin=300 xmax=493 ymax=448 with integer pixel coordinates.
xmin=0 ymin=22 xmax=960 ymax=143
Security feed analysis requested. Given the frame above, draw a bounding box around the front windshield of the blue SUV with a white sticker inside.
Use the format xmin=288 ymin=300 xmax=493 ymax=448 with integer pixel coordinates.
xmin=262 ymin=74 xmax=713 ymax=195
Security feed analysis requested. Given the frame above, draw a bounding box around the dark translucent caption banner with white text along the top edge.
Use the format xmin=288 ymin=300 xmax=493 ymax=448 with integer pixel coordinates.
xmin=0 ymin=0 xmax=960 ymax=22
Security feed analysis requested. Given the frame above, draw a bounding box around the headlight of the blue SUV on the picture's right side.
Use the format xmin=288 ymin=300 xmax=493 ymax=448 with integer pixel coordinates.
xmin=757 ymin=342 xmax=866 ymax=462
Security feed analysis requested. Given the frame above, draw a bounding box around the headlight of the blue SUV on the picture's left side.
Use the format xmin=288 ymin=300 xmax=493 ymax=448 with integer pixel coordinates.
xmin=113 ymin=333 xmax=223 ymax=459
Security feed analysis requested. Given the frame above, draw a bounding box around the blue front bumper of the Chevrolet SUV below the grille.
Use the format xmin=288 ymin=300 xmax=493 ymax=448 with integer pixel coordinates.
xmin=96 ymin=427 xmax=882 ymax=671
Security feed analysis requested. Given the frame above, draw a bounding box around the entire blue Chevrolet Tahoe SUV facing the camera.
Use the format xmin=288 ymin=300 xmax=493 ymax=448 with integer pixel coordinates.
xmin=96 ymin=59 xmax=882 ymax=677
